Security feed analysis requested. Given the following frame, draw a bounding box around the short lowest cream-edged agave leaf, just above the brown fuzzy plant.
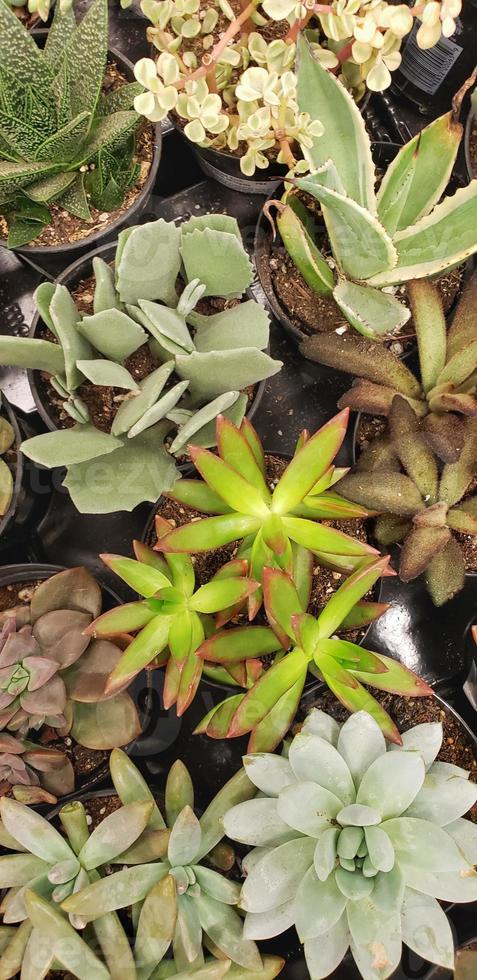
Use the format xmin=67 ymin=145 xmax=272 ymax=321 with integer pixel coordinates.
xmin=333 ymin=279 xmax=411 ymax=337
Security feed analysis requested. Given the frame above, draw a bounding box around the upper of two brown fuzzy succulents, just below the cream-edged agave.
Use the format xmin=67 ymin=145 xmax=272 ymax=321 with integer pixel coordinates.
xmin=300 ymin=274 xmax=477 ymax=463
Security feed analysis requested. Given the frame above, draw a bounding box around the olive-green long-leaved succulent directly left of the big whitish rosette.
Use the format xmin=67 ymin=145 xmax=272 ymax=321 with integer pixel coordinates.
xmin=62 ymin=750 xmax=272 ymax=976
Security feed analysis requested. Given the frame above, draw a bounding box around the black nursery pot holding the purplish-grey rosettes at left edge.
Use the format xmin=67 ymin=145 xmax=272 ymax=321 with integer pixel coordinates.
xmin=0 ymin=563 xmax=152 ymax=801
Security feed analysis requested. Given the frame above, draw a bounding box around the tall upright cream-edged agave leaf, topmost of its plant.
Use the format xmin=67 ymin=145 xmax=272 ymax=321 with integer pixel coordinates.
xmin=298 ymin=34 xmax=376 ymax=212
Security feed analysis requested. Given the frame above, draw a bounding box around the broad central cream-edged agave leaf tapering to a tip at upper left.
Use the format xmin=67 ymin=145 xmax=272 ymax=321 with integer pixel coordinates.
xmin=296 ymin=174 xmax=397 ymax=285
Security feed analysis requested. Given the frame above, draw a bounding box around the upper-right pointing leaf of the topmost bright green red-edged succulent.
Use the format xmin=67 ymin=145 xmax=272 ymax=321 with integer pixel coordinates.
xmin=272 ymin=410 xmax=349 ymax=514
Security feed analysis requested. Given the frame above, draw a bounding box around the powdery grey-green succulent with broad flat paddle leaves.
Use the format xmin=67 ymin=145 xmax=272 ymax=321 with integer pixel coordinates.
xmin=0 ymin=214 xmax=281 ymax=513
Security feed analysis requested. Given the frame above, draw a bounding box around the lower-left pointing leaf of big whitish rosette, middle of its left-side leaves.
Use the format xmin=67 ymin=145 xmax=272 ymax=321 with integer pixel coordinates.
xmin=241 ymin=837 xmax=315 ymax=912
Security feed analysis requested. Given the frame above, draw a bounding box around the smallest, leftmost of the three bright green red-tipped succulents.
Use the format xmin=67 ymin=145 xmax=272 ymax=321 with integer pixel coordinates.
xmin=85 ymin=532 xmax=259 ymax=715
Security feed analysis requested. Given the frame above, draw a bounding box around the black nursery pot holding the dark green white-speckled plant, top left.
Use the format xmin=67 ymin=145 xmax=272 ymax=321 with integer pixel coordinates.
xmin=0 ymin=28 xmax=162 ymax=258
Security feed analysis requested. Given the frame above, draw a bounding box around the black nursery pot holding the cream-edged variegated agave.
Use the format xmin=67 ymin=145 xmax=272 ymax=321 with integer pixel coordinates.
xmin=254 ymin=143 xmax=473 ymax=344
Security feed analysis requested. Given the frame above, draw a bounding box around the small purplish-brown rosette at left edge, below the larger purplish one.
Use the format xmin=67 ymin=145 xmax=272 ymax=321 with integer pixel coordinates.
xmin=0 ymin=732 xmax=75 ymax=803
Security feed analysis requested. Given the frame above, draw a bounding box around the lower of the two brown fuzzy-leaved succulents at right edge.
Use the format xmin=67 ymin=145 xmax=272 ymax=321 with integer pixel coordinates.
xmin=339 ymin=395 xmax=477 ymax=606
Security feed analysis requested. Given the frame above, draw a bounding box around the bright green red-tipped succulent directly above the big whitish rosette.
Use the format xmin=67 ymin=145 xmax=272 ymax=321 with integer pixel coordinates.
xmin=196 ymin=558 xmax=433 ymax=752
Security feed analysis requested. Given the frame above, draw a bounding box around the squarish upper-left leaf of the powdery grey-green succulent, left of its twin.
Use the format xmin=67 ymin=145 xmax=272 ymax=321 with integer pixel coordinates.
xmin=116 ymin=218 xmax=181 ymax=306
